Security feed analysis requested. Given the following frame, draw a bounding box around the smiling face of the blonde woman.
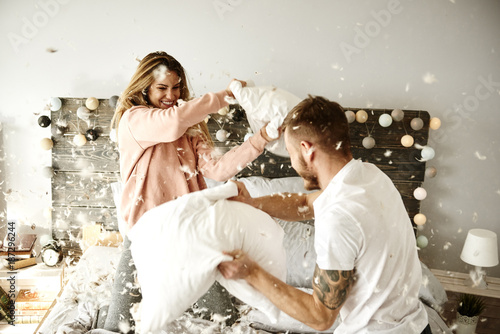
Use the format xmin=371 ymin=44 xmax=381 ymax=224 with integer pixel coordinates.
xmin=148 ymin=71 xmax=181 ymax=109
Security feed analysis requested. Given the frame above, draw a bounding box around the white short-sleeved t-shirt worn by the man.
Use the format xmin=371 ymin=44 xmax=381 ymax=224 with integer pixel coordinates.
xmin=314 ymin=159 xmax=428 ymax=334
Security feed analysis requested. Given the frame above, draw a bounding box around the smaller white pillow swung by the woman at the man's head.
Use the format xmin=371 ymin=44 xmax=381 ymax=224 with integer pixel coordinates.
xmin=229 ymin=80 xmax=301 ymax=157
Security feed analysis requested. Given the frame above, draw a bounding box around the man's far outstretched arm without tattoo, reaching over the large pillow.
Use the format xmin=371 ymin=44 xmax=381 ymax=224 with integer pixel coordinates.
xmin=230 ymin=181 xmax=321 ymax=221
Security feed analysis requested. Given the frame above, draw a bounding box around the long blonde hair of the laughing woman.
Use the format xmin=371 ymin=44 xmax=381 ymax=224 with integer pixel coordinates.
xmin=111 ymin=51 xmax=213 ymax=147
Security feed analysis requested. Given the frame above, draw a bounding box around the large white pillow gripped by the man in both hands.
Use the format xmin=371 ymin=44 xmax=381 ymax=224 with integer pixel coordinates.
xmin=128 ymin=182 xmax=286 ymax=333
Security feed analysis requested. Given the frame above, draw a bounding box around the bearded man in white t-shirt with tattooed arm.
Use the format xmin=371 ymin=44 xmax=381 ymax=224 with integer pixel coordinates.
xmin=219 ymin=96 xmax=430 ymax=334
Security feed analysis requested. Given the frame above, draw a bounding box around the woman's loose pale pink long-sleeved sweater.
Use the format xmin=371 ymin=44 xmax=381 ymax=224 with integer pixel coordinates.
xmin=118 ymin=91 xmax=267 ymax=228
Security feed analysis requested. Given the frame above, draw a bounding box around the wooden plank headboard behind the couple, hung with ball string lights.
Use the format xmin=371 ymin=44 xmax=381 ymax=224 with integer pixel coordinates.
xmin=51 ymin=98 xmax=429 ymax=255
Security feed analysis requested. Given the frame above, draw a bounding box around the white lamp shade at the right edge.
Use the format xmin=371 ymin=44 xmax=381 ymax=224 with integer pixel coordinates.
xmin=460 ymin=228 xmax=498 ymax=267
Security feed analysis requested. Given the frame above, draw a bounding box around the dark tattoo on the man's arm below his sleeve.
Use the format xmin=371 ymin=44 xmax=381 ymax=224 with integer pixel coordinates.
xmin=312 ymin=265 xmax=354 ymax=310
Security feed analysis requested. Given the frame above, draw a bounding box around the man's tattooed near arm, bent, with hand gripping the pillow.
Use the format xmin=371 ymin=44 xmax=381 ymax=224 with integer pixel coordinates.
xmin=219 ymin=251 xmax=354 ymax=331
